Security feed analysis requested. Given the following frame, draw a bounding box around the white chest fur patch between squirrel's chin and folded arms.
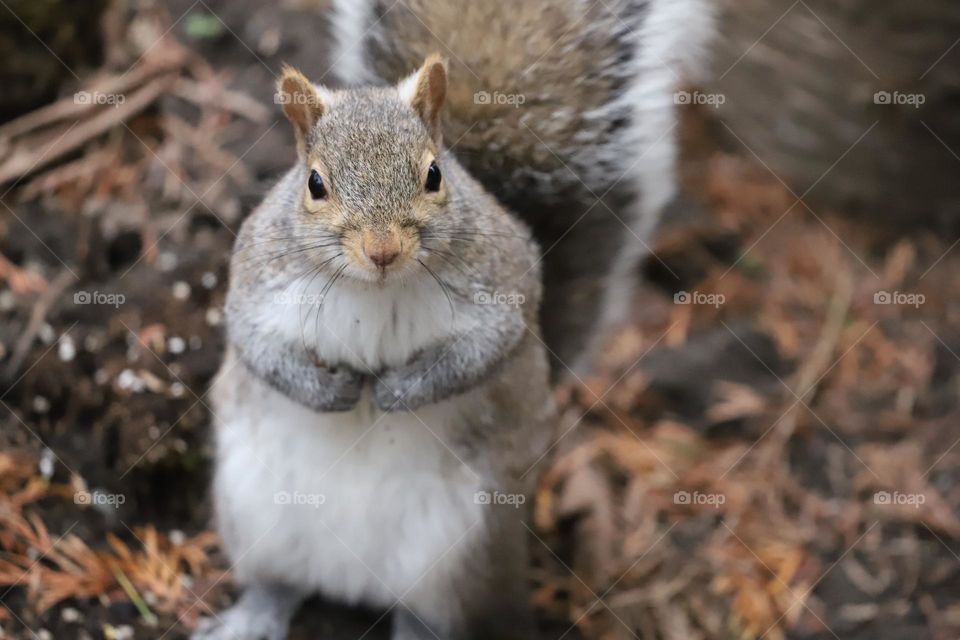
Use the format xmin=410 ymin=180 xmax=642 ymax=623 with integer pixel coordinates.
xmin=262 ymin=278 xmax=462 ymax=370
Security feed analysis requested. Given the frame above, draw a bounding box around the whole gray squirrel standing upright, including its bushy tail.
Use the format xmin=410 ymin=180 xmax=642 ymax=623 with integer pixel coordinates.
xmin=193 ymin=0 xmax=704 ymax=640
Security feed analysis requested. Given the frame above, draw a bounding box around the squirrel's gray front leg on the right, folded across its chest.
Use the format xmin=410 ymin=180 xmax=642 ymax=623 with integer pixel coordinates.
xmin=373 ymin=305 xmax=526 ymax=411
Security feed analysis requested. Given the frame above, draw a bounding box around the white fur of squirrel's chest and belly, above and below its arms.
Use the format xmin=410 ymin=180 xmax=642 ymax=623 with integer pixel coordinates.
xmin=214 ymin=279 xmax=483 ymax=606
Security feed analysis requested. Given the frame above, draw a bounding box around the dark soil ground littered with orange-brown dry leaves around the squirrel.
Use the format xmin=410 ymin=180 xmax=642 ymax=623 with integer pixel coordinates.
xmin=0 ymin=0 xmax=960 ymax=640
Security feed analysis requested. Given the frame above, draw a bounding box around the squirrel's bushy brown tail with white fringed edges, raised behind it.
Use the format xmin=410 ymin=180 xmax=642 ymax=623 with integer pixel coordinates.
xmin=332 ymin=0 xmax=711 ymax=371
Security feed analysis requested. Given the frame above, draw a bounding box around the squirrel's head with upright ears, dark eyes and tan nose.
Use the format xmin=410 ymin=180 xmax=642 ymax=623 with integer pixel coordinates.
xmin=278 ymin=56 xmax=450 ymax=282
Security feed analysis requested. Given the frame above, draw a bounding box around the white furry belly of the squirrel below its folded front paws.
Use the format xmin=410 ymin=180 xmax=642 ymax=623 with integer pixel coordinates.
xmin=214 ymin=358 xmax=482 ymax=606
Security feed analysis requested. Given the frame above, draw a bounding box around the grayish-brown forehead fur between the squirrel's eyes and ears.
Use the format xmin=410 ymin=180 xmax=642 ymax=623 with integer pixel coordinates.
xmin=308 ymin=89 xmax=436 ymax=215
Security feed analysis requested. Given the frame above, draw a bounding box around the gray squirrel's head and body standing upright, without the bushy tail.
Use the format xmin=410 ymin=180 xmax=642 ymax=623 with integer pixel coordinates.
xmin=193 ymin=57 xmax=554 ymax=640
